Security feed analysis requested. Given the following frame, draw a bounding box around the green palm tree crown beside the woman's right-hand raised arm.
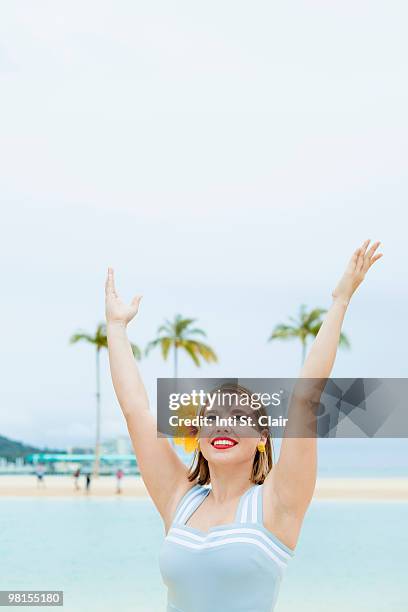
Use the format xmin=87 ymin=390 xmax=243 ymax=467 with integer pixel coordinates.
xmin=268 ymin=304 xmax=350 ymax=364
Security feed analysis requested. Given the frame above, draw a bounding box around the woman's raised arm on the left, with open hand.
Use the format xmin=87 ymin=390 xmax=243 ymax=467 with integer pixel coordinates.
xmin=105 ymin=268 xmax=191 ymax=526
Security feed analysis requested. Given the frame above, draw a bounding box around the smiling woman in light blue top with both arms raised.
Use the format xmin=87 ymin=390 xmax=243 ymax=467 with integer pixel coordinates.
xmin=106 ymin=240 xmax=381 ymax=612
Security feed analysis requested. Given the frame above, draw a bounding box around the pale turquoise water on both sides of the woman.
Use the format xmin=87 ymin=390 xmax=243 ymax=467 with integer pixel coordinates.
xmin=0 ymin=498 xmax=408 ymax=612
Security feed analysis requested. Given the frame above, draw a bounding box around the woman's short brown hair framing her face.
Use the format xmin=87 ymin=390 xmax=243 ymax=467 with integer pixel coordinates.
xmin=188 ymin=384 xmax=274 ymax=485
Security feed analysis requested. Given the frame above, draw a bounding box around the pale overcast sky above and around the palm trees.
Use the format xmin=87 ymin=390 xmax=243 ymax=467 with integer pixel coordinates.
xmin=0 ymin=0 xmax=408 ymax=446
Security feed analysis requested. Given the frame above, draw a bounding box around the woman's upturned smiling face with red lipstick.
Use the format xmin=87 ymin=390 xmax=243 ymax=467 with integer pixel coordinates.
xmin=199 ymin=404 xmax=267 ymax=465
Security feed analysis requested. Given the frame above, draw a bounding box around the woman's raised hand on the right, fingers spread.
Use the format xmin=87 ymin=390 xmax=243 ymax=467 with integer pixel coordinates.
xmin=332 ymin=240 xmax=383 ymax=302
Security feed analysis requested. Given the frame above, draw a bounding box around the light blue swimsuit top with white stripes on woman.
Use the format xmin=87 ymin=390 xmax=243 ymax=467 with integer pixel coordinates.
xmin=159 ymin=485 xmax=294 ymax=612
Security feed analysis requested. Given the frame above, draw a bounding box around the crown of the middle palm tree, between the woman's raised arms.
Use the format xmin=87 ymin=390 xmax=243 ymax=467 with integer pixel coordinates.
xmin=146 ymin=315 xmax=218 ymax=378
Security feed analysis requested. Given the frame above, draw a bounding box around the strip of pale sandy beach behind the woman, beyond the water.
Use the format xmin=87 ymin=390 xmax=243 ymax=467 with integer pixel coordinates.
xmin=0 ymin=475 xmax=408 ymax=501
